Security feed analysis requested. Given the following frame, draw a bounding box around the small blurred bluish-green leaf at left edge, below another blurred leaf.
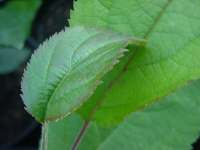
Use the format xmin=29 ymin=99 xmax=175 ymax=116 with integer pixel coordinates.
xmin=0 ymin=46 xmax=30 ymax=74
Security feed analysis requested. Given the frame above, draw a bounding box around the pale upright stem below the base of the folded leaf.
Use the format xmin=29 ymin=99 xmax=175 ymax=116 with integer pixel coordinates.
xmin=41 ymin=122 xmax=48 ymax=150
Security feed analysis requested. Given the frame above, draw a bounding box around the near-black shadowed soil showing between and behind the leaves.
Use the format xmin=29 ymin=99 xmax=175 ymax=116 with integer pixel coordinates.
xmin=0 ymin=0 xmax=200 ymax=150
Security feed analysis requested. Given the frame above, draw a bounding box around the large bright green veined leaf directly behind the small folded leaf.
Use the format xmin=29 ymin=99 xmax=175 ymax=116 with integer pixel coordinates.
xmin=70 ymin=0 xmax=200 ymax=125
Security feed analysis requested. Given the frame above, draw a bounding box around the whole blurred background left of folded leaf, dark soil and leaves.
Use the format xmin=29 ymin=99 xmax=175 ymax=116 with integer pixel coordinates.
xmin=0 ymin=0 xmax=200 ymax=150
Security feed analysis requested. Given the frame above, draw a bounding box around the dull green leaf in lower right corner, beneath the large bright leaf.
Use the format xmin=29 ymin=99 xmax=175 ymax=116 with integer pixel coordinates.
xmin=98 ymin=81 xmax=200 ymax=150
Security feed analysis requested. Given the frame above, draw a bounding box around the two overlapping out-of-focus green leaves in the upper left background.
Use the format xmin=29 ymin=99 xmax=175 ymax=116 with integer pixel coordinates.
xmin=0 ymin=0 xmax=40 ymax=74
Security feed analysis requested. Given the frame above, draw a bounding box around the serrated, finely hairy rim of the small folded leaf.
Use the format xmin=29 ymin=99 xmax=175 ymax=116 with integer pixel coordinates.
xmin=20 ymin=26 xmax=146 ymax=123
